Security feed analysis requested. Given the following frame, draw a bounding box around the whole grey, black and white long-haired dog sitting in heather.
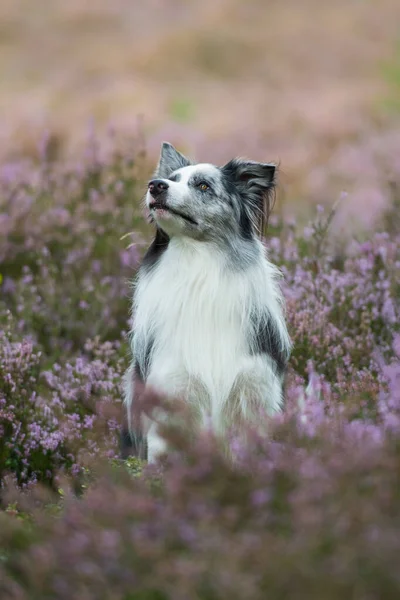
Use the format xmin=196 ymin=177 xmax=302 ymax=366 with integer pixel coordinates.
xmin=122 ymin=143 xmax=291 ymax=462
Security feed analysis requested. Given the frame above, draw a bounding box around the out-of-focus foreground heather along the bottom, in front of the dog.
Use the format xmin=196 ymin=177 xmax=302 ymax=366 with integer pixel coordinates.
xmin=0 ymin=378 xmax=400 ymax=600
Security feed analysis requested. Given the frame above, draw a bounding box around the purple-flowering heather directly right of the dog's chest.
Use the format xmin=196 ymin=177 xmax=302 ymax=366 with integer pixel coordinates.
xmin=270 ymin=207 xmax=400 ymax=384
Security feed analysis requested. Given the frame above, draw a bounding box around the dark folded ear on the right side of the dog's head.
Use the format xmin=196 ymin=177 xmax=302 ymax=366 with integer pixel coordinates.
xmin=222 ymin=158 xmax=276 ymax=236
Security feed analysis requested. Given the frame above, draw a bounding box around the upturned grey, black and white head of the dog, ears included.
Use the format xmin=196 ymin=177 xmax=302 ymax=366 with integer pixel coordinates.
xmin=146 ymin=142 xmax=275 ymax=240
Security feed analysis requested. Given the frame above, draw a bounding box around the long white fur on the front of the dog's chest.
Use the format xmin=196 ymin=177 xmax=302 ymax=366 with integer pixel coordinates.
xmin=135 ymin=242 xmax=249 ymax=399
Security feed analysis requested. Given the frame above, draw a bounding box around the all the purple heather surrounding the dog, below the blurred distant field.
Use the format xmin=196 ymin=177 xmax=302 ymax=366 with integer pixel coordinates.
xmin=0 ymin=134 xmax=400 ymax=600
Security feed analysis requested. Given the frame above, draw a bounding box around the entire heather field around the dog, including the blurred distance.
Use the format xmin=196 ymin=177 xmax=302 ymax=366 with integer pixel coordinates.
xmin=0 ymin=0 xmax=400 ymax=600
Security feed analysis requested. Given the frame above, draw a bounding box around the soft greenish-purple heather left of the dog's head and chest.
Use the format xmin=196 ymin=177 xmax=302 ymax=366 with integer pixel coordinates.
xmin=0 ymin=137 xmax=145 ymax=354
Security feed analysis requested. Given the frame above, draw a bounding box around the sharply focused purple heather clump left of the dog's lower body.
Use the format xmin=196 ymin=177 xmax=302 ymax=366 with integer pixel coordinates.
xmin=0 ymin=314 xmax=122 ymax=486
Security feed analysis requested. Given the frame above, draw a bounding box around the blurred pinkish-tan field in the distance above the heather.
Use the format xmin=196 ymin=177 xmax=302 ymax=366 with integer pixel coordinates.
xmin=0 ymin=0 xmax=400 ymax=227
